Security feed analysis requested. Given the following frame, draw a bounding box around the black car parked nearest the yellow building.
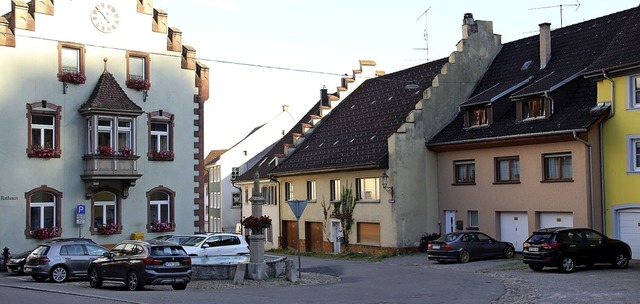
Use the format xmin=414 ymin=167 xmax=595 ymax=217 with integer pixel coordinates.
xmin=522 ymin=227 xmax=631 ymax=272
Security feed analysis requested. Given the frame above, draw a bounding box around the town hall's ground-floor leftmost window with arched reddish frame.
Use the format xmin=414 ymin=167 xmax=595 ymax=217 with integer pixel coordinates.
xmin=25 ymin=186 xmax=62 ymax=238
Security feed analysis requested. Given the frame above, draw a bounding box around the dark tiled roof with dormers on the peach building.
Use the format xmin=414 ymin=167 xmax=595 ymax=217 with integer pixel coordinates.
xmin=427 ymin=8 xmax=640 ymax=146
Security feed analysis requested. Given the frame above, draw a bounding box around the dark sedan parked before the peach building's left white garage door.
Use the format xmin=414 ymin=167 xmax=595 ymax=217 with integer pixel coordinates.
xmin=427 ymin=231 xmax=515 ymax=263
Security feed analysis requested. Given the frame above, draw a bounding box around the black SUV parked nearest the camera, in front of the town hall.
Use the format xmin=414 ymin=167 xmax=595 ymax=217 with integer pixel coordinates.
xmin=88 ymin=240 xmax=191 ymax=291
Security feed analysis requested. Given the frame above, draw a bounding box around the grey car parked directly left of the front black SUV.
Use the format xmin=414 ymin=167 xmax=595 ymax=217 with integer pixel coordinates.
xmin=24 ymin=238 xmax=109 ymax=283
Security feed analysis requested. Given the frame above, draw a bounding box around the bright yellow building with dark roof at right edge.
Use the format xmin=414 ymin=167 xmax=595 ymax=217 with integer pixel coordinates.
xmin=584 ymin=8 xmax=640 ymax=259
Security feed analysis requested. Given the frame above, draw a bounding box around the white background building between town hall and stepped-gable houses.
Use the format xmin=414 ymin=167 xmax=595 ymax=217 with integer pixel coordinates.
xmin=205 ymin=105 xmax=296 ymax=232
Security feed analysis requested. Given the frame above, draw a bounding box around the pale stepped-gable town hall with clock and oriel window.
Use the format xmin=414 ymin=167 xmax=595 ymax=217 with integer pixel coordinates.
xmin=0 ymin=0 xmax=209 ymax=252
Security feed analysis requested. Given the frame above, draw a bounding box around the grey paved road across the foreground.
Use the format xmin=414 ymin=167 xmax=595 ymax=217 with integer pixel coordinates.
xmin=0 ymin=254 xmax=640 ymax=304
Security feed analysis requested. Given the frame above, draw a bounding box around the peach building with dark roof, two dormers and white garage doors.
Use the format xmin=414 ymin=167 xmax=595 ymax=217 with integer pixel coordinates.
xmin=427 ymin=9 xmax=637 ymax=251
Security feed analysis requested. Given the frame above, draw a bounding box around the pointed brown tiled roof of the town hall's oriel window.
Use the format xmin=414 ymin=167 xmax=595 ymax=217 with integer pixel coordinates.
xmin=79 ymin=71 xmax=143 ymax=115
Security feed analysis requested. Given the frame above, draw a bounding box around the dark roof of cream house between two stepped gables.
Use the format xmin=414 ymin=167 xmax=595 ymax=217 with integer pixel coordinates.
xmin=271 ymin=58 xmax=448 ymax=175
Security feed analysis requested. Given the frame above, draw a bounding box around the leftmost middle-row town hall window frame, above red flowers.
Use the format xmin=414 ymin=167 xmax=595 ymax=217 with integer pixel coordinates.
xmin=26 ymin=100 xmax=62 ymax=158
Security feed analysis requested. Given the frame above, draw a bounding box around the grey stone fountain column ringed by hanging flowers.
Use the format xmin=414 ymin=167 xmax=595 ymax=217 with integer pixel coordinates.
xmin=247 ymin=172 xmax=267 ymax=280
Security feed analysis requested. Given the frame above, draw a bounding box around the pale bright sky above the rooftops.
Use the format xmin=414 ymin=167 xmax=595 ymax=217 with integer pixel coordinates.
xmin=6 ymin=0 xmax=640 ymax=155
